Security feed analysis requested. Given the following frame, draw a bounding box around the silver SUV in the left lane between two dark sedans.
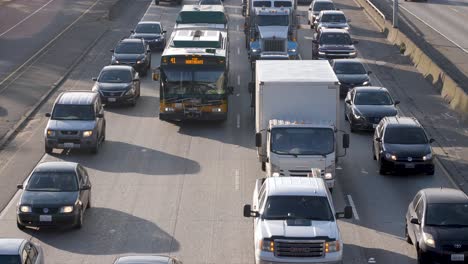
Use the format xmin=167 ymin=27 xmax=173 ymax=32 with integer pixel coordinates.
xmin=44 ymin=91 xmax=106 ymax=154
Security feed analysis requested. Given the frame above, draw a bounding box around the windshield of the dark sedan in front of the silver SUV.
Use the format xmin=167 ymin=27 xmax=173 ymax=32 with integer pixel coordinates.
xmin=26 ymin=171 xmax=78 ymax=192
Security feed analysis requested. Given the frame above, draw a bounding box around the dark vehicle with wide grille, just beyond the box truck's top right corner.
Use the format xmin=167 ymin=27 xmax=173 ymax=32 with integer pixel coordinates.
xmin=312 ymin=28 xmax=357 ymax=59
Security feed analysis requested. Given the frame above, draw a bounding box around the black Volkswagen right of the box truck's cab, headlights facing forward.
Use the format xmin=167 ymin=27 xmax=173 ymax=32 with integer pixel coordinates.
xmin=372 ymin=116 xmax=434 ymax=175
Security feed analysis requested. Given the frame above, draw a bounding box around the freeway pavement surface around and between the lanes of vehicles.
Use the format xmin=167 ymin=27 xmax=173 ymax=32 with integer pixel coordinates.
xmin=0 ymin=0 xmax=466 ymax=264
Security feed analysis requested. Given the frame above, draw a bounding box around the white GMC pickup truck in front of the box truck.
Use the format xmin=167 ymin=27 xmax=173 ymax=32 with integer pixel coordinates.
xmin=244 ymin=177 xmax=353 ymax=264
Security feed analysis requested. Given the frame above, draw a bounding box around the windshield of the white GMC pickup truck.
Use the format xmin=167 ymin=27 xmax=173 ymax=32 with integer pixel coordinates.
xmin=262 ymin=196 xmax=334 ymax=221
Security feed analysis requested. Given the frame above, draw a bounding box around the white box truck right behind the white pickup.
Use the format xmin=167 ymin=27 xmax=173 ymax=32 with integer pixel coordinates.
xmin=254 ymin=60 xmax=349 ymax=189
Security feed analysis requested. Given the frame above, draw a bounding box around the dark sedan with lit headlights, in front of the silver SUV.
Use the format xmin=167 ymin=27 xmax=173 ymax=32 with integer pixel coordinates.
xmin=17 ymin=162 xmax=91 ymax=229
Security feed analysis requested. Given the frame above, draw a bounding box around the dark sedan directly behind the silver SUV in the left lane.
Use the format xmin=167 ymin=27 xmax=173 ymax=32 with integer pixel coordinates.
xmin=93 ymin=65 xmax=140 ymax=106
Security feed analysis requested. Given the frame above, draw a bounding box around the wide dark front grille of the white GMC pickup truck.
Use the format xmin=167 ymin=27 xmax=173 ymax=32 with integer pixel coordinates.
xmin=275 ymin=240 xmax=325 ymax=258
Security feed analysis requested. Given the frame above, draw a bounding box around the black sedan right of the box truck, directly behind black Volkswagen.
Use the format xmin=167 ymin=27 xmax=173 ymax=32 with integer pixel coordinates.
xmin=344 ymin=86 xmax=400 ymax=132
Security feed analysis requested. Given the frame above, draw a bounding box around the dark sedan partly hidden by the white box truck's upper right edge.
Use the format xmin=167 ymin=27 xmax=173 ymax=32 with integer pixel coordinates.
xmin=331 ymin=59 xmax=372 ymax=97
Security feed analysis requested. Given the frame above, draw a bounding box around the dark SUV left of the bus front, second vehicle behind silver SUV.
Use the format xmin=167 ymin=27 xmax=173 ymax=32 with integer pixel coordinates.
xmin=111 ymin=38 xmax=151 ymax=76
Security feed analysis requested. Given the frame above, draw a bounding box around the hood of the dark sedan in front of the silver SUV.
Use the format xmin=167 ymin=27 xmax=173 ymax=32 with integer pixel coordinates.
xmin=20 ymin=191 xmax=79 ymax=206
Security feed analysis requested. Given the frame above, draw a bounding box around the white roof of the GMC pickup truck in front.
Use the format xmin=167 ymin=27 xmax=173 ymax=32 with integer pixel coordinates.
xmin=265 ymin=177 xmax=327 ymax=196
